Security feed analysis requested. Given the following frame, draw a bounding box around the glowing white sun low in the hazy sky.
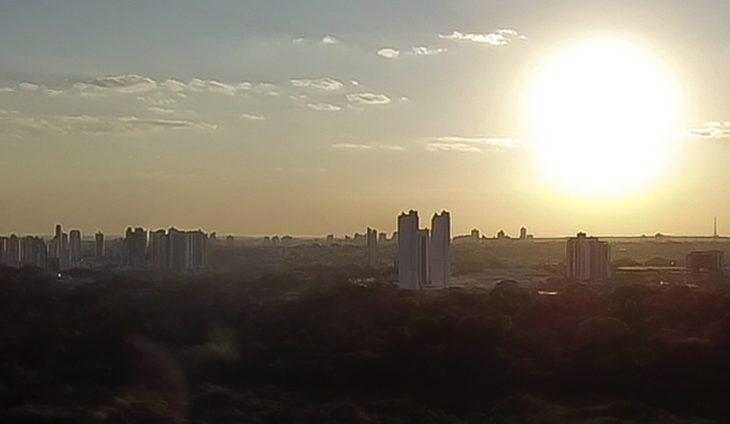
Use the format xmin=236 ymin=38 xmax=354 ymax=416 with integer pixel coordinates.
xmin=526 ymin=38 xmax=681 ymax=195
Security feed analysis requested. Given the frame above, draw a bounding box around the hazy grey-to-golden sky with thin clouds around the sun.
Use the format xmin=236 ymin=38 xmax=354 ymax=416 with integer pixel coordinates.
xmin=0 ymin=0 xmax=730 ymax=236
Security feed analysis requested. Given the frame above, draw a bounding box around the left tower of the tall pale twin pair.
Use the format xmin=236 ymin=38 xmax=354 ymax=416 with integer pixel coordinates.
xmin=398 ymin=210 xmax=422 ymax=290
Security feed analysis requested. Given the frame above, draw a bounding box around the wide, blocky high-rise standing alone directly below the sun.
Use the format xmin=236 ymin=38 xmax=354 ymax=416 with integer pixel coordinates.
xmin=565 ymin=233 xmax=611 ymax=283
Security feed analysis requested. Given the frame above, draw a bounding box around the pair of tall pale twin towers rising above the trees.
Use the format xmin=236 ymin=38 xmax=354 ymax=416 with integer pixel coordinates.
xmin=398 ymin=210 xmax=451 ymax=290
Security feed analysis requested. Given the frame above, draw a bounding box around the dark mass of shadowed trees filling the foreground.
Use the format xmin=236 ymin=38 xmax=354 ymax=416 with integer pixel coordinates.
xmin=0 ymin=271 xmax=730 ymax=424
